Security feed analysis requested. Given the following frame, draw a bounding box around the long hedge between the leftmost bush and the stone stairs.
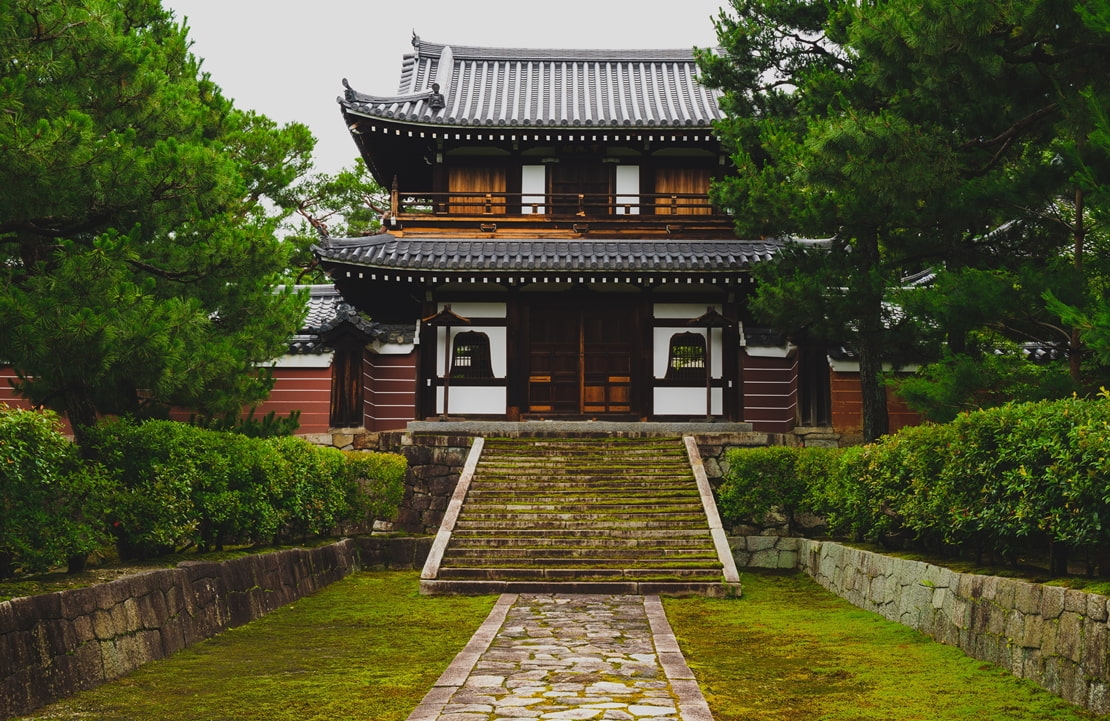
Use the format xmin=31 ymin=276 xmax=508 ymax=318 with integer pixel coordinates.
xmin=85 ymin=419 xmax=405 ymax=558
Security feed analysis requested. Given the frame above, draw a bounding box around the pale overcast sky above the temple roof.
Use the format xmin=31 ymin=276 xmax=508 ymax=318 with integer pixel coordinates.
xmin=162 ymin=0 xmax=728 ymax=173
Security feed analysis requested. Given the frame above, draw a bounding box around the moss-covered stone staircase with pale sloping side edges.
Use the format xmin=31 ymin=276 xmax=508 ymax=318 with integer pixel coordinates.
xmin=421 ymin=437 xmax=739 ymax=596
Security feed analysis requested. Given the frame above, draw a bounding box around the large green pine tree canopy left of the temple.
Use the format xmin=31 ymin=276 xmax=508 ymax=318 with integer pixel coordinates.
xmin=0 ymin=0 xmax=314 ymax=435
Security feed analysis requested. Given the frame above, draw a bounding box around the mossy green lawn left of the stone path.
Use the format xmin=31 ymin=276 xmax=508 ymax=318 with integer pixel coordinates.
xmin=15 ymin=571 xmax=496 ymax=721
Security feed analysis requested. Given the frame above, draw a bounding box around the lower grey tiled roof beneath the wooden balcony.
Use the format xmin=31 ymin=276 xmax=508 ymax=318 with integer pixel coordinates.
xmin=314 ymin=234 xmax=783 ymax=273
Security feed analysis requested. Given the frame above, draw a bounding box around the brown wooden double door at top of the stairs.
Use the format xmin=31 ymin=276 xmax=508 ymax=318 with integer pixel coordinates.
xmin=527 ymin=303 xmax=636 ymax=415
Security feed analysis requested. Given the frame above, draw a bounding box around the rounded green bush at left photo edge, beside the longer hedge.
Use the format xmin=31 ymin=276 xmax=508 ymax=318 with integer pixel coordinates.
xmin=0 ymin=405 xmax=109 ymax=578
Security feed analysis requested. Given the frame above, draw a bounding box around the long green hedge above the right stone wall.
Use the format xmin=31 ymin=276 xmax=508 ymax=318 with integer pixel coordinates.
xmin=718 ymin=393 xmax=1110 ymax=572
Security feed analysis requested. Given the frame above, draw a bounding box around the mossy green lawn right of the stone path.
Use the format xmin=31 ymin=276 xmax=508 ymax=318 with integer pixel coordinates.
xmin=664 ymin=573 xmax=1110 ymax=721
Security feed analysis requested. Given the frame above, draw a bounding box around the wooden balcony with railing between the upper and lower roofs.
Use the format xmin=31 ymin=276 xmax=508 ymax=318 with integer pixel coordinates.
xmin=386 ymin=190 xmax=735 ymax=240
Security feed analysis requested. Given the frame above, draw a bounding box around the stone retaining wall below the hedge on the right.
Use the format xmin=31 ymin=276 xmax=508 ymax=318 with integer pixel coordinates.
xmin=729 ymin=536 xmax=1110 ymax=713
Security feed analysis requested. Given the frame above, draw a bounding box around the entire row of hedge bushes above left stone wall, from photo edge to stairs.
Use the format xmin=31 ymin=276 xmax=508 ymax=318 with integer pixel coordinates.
xmin=0 ymin=406 xmax=406 ymax=578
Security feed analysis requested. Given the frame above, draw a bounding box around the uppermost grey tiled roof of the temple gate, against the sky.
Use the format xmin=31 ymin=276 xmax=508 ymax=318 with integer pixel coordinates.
xmin=340 ymin=35 xmax=723 ymax=128
